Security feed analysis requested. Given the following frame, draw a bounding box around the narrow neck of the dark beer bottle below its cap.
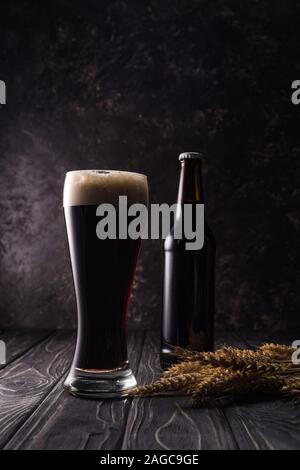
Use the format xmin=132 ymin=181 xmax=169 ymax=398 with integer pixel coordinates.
xmin=177 ymin=159 xmax=204 ymax=204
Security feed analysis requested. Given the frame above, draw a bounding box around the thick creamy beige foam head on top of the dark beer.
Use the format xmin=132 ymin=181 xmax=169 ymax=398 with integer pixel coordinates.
xmin=64 ymin=170 xmax=148 ymax=206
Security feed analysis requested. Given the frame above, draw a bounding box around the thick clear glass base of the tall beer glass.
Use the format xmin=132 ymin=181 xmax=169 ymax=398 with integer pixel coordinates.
xmin=64 ymin=365 xmax=136 ymax=398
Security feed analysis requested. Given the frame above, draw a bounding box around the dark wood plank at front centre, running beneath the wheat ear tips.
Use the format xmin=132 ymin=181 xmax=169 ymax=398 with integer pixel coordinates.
xmin=123 ymin=332 xmax=237 ymax=450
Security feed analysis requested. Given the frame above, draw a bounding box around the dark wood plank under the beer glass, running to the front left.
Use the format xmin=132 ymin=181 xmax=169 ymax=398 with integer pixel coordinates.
xmin=5 ymin=331 xmax=145 ymax=450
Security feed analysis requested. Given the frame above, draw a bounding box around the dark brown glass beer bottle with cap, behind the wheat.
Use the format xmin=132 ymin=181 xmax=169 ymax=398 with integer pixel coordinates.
xmin=161 ymin=152 xmax=216 ymax=367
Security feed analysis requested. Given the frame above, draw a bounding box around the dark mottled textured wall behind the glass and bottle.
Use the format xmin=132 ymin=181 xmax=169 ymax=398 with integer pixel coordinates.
xmin=0 ymin=0 xmax=300 ymax=331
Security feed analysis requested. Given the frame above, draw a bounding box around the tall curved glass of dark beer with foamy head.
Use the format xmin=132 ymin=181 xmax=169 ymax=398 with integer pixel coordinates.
xmin=64 ymin=170 xmax=148 ymax=398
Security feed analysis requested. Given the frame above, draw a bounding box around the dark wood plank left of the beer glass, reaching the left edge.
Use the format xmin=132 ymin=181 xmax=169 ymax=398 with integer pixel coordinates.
xmin=0 ymin=331 xmax=74 ymax=447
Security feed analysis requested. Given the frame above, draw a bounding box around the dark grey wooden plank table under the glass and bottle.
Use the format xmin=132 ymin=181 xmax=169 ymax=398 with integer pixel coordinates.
xmin=0 ymin=330 xmax=300 ymax=450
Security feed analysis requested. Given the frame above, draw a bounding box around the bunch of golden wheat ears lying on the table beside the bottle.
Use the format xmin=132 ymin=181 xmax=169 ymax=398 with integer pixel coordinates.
xmin=130 ymin=343 xmax=300 ymax=405
